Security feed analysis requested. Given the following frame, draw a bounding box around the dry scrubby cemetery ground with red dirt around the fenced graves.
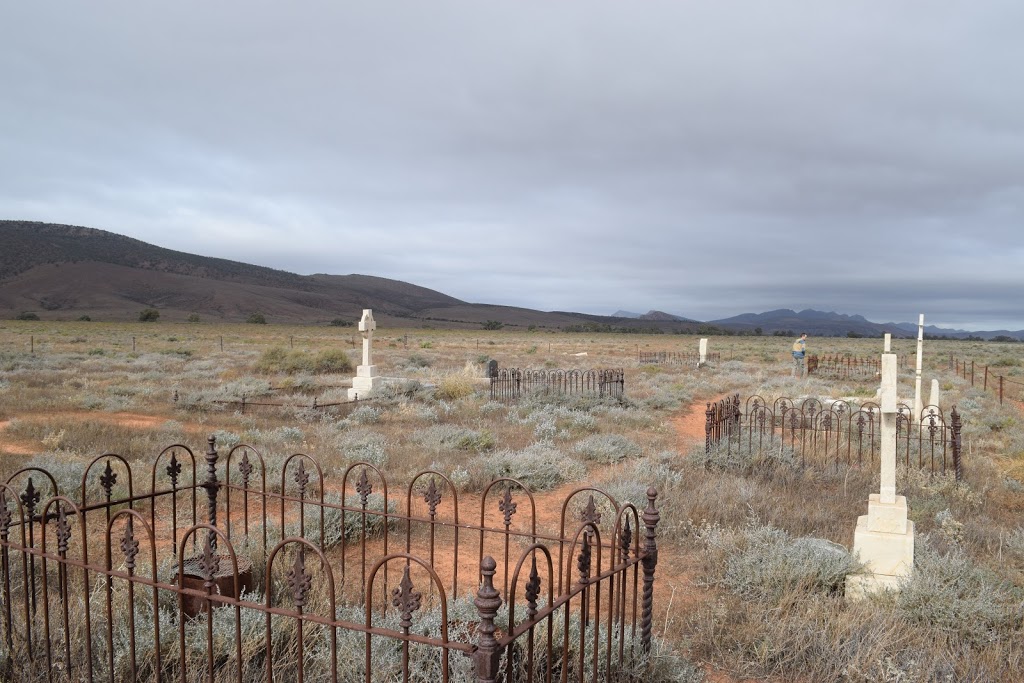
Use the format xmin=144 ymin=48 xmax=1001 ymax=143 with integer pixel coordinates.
xmin=0 ymin=322 xmax=1024 ymax=681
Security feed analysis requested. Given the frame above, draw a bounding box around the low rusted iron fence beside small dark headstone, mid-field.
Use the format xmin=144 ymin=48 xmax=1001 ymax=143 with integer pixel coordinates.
xmin=490 ymin=368 xmax=626 ymax=400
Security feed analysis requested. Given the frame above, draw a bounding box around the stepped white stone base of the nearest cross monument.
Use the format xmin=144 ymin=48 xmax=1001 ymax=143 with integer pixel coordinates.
xmin=846 ymin=494 xmax=913 ymax=600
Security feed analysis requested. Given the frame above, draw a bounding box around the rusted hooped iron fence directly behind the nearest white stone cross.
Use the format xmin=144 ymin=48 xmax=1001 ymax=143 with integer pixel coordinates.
xmin=705 ymin=394 xmax=964 ymax=481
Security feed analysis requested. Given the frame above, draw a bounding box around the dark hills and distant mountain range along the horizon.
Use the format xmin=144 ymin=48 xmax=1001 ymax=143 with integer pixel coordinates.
xmin=0 ymin=220 xmax=1024 ymax=340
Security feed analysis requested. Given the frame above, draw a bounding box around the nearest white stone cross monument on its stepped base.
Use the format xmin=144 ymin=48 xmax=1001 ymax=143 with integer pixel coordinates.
xmin=846 ymin=333 xmax=924 ymax=600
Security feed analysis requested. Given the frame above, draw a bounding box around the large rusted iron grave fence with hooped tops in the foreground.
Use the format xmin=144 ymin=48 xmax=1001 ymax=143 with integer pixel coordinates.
xmin=0 ymin=437 xmax=658 ymax=682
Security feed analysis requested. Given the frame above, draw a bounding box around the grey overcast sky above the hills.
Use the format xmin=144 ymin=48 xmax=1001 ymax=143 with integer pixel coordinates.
xmin=0 ymin=0 xmax=1024 ymax=330
